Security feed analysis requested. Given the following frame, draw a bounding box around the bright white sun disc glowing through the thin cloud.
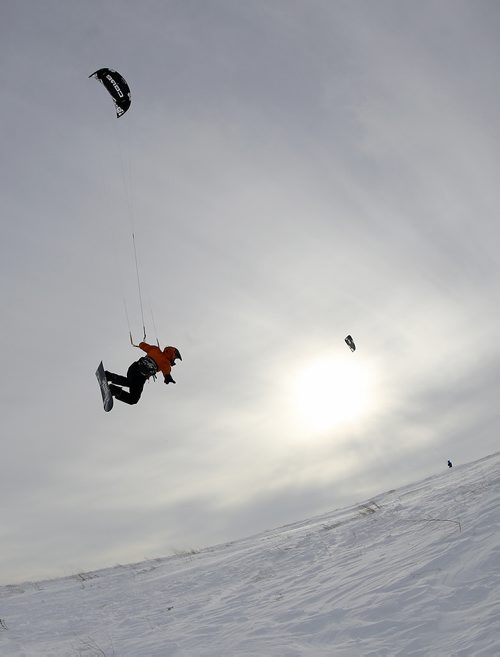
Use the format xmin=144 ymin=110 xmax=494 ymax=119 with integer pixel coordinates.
xmin=294 ymin=354 xmax=375 ymax=432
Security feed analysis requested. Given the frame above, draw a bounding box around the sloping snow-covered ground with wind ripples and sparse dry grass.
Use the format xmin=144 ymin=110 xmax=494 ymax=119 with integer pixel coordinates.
xmin=0 ymin=453 xmax=500 ymax=657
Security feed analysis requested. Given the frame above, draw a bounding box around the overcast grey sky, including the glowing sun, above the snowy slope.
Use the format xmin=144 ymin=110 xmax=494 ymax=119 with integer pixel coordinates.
xmin=0 ymin=0 xmax=500 ymax=583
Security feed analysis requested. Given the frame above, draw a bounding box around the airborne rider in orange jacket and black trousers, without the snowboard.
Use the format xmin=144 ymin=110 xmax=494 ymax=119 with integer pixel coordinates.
xmin=105 ymin=342 xmax=182 ymax=404
